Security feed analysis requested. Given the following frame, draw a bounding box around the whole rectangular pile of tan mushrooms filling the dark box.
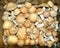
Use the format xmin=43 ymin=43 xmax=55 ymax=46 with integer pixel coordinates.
xmin=2 ymin=1 xmax=58 ymax=47
